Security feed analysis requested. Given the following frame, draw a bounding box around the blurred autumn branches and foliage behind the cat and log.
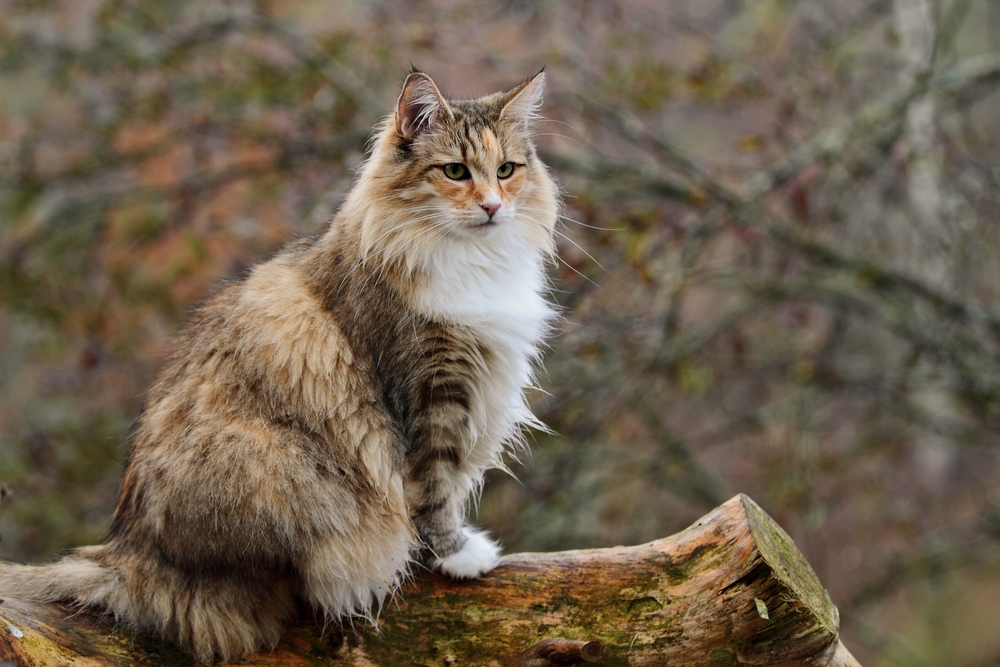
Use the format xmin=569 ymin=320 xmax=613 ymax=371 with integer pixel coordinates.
xmin=0 ymin=0 xmax=1000 ymax=667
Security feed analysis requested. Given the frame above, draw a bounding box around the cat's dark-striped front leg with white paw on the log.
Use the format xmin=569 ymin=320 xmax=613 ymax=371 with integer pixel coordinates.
xmin=407 ymin=392 xmax=500 ymax=579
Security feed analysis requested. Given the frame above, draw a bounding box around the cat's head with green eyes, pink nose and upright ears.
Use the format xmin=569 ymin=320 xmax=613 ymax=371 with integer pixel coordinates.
xmin=359 ymin=70 xmax=558 ymax=272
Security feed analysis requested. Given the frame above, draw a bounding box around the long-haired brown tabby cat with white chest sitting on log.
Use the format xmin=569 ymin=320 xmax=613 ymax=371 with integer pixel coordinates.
xmin=0 ymin=69 xmax=560 ymax=663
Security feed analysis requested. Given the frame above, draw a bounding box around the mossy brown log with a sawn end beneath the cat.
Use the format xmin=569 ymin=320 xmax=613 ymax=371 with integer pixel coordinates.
xmin=0 ymin=495 xmax=859 ymax=667
